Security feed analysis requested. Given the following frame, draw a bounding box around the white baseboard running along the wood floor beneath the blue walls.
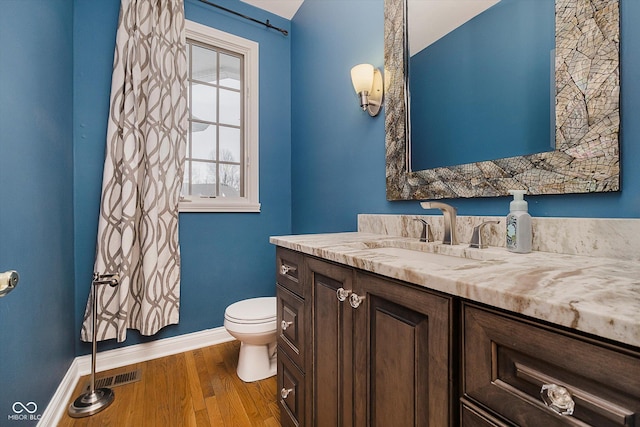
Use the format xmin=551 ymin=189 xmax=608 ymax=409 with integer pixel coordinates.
xmin=38 ymin=326 xmax=234 ymax=427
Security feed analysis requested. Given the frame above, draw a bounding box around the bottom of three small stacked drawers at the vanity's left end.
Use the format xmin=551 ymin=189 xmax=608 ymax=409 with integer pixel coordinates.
xmin=277 ymin=353 xmax=305 ymax=426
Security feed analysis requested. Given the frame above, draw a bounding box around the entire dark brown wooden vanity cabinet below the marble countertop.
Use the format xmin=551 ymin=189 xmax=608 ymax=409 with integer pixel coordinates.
xmin=277 ymin=247 xmax=640 ymax=427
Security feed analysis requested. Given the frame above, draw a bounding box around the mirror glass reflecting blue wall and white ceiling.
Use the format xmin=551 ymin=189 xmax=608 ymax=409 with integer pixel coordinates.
xmin=407 ymin=0 xmax=555 ymax=170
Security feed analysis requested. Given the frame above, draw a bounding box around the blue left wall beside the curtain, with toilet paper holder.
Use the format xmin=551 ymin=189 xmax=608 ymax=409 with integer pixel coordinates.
xmin=0 ymin=0 xmax=77 ymax=426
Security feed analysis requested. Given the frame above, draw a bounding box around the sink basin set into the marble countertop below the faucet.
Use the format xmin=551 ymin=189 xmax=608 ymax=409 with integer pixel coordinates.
xmin=364 ymin=239 xmax=502 ymax=266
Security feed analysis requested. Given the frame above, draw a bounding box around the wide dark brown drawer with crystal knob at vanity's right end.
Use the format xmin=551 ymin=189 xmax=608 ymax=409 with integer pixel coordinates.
xmin=463 ymin=305 xmax=640 ymax=427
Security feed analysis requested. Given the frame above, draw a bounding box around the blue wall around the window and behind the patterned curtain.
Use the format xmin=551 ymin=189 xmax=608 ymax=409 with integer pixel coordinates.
xmin=74 ymin=0 xmax=291 ymax=354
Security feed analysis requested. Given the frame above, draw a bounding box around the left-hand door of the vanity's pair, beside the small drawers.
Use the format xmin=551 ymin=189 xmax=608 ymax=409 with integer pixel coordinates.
xmin=306 ymin=258 xmax=354 ymax=427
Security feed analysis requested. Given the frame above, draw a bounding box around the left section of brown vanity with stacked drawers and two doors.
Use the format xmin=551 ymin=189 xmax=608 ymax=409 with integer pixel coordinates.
xmin=277 ymin=248 xmax=456 ymax=427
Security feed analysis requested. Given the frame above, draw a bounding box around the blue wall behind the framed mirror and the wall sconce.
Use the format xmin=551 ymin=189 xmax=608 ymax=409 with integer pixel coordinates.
xmin=291 ymin=0 xmax=640 ymax=233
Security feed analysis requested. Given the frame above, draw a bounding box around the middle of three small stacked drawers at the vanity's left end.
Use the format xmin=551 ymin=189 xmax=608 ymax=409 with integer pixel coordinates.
xmin=276 ymin=285 xmax=307 ymax=367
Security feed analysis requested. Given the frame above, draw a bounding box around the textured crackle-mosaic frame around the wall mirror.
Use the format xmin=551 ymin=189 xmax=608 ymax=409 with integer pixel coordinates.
xmin=385 ymin=0 xmax=620 ymax=200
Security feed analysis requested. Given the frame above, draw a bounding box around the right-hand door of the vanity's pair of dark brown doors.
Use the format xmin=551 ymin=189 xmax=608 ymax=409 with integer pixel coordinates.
xmin=354 ymin=273 xmax=457 ymax=427
